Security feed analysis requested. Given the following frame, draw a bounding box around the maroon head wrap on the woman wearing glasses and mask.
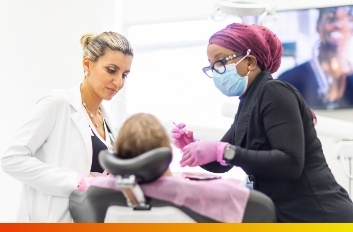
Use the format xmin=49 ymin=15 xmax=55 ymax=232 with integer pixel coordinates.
xmin=209 ymin=23 xmax=283 ymax=73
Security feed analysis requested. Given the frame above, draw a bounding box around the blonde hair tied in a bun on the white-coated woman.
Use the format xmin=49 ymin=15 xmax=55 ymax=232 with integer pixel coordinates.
xmin=81 ymin=31 xmax=134 ymax=61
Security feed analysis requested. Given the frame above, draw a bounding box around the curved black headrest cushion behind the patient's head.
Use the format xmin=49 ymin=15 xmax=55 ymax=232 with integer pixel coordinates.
xmin=98 ymin=147 xmax=172 ymax=183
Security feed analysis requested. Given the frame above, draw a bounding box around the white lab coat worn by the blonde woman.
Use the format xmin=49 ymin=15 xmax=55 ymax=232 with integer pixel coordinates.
xmin=1 ymin=86 xmax=115 ymax=222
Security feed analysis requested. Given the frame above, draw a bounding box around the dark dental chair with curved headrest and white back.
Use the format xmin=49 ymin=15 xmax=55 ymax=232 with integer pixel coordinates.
xmin=69 ymin=147 xmax=276 ymax=223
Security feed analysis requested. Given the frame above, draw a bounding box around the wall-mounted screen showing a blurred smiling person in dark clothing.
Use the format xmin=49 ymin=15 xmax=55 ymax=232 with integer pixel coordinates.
xmin=271 ymin=5 xmax=353 ymax=109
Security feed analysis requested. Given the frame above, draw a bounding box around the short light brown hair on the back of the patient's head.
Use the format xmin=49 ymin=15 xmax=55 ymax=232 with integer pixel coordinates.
xmin=114 ymin=113 xmax=171 ymax=159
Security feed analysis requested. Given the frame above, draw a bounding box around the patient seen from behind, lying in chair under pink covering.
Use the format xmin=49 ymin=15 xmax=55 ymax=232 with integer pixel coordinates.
xmin=78 ymin=113 xmax=249 ymax=222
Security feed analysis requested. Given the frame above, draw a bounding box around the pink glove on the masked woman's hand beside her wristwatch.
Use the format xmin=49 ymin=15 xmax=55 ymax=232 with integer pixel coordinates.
xmin=180 ymin=141 xmax=229 ymax=167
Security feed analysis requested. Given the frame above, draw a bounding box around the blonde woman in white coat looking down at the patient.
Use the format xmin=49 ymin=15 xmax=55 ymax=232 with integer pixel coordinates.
xmin=1 ymin=32 xmax=133 ymax=222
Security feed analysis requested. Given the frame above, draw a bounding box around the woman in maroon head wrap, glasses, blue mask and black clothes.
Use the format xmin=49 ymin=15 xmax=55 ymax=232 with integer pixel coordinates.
xmin=172 ymin=23 xmax=353 ymax=222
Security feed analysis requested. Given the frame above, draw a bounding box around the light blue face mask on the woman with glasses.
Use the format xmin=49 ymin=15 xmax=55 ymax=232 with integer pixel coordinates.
xmin=213 ymin=56 xmax=250 ymax=97
